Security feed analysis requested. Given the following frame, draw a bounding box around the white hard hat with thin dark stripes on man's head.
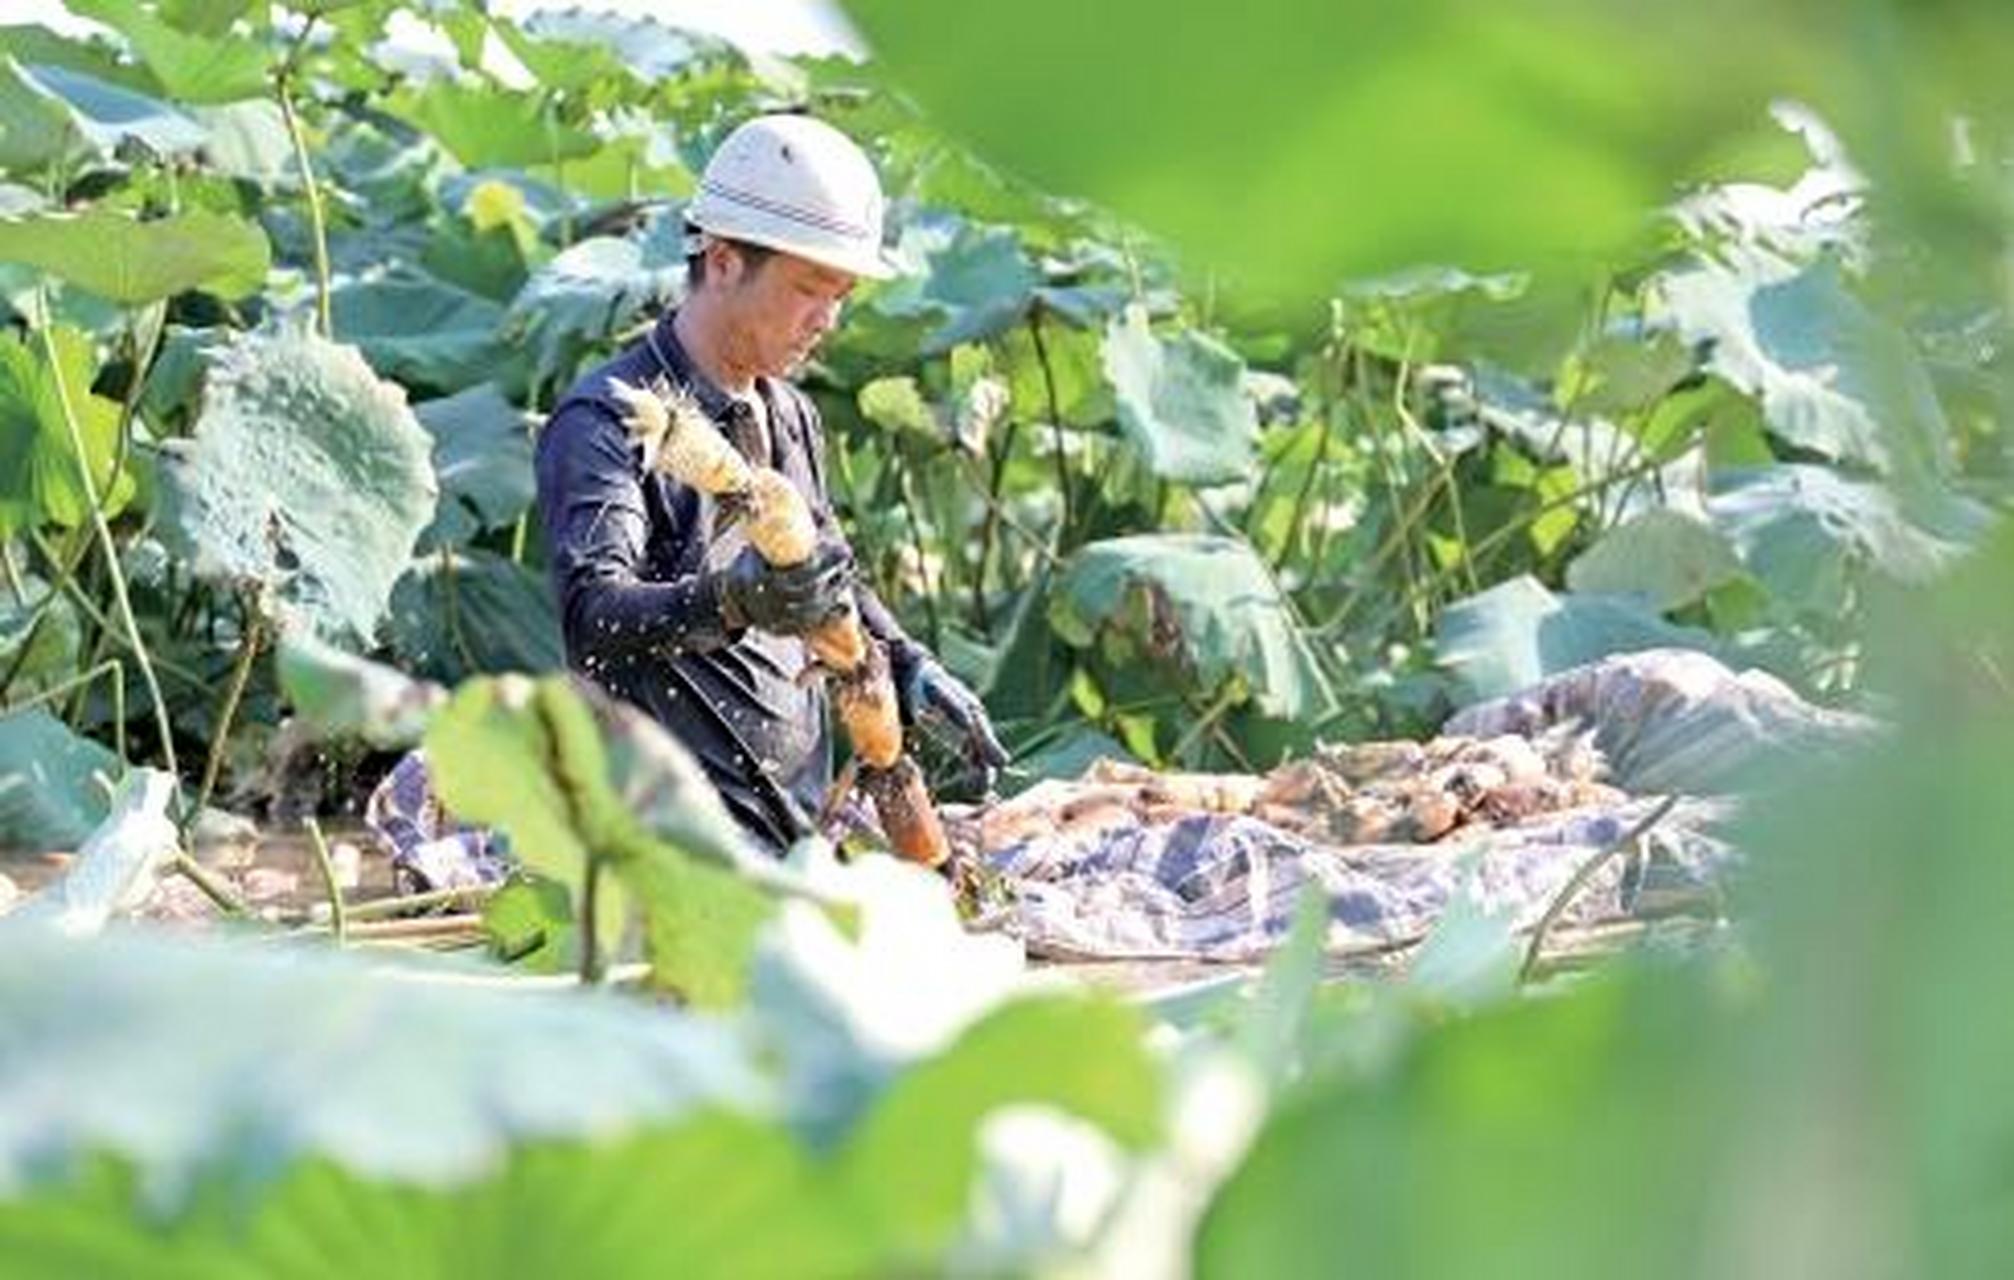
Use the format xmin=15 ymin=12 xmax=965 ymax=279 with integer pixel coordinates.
xmin=685 ymin=115 xmax=896 ymax=280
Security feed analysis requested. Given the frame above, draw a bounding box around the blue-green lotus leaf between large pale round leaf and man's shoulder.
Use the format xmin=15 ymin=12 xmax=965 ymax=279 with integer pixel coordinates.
xmin=413 ymin=382 xmax=538 ymax=547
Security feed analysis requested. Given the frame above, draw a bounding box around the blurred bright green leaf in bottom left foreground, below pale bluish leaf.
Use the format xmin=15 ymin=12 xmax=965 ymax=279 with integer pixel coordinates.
xmin=0 ymin=1110 xmax=884 ymax=1280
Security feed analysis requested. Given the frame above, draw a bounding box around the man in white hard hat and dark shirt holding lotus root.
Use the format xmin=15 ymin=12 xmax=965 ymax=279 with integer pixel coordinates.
xmin=538 ymin=115 xmax=1007 ymax=849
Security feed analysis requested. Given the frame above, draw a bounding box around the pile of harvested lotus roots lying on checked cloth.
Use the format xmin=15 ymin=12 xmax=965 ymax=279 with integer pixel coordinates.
xmin=951 ymin=733 xmax=1623 ymax=853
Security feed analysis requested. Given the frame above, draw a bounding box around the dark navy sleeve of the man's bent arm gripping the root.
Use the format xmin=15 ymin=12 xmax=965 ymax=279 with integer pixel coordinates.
xmin=538 ymin=401 xmax=735 ymax=672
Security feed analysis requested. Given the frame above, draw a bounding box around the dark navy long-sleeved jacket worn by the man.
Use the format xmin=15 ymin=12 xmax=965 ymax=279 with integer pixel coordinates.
xmin=538 ymin=314 xmax=910 ymax=849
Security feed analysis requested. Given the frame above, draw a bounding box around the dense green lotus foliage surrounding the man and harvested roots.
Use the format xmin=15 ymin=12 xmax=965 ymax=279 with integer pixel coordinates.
xmin=0 ymin=0 xmax=2014 ymax=1276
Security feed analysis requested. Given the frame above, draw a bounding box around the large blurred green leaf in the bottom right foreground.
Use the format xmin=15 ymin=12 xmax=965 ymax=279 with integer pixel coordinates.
xmin=1194 ymin=972 xmax=1734 ymax=1278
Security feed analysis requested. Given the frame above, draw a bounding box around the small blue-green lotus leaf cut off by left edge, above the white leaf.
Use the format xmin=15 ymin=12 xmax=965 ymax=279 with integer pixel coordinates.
xmin=0 ymin=706 xmax=125 ymax=849
